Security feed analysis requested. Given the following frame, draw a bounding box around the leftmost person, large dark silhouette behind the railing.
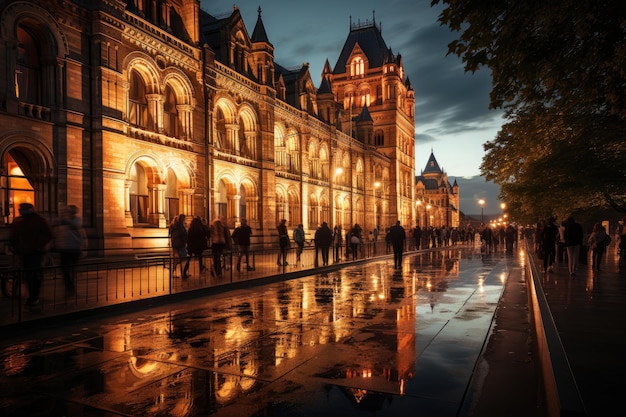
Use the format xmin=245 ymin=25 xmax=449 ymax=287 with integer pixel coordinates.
xmin=10 ymin=203 xmax=53 ymax=306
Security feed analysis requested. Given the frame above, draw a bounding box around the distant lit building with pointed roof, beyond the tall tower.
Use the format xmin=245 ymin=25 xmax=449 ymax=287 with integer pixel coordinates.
xmin=415 ymin=152 xmax=460 ymax=227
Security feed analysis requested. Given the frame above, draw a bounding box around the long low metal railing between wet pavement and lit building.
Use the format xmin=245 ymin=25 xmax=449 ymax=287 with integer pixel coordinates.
xmin=0 ymin=239 xmax=448 ymax=326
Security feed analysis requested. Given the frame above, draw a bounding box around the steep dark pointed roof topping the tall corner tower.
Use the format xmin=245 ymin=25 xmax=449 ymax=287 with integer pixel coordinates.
xmin=333 ymin=21 xmax=389 ymax=74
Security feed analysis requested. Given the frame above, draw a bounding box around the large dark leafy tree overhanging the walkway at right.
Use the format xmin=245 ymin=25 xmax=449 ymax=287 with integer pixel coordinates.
xmin=432 ymin=0 xmax=626 ymax=219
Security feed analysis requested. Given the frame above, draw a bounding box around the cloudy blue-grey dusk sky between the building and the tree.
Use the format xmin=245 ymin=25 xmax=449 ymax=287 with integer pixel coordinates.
xmin=201 ymin=0 xmax=503 ymax=214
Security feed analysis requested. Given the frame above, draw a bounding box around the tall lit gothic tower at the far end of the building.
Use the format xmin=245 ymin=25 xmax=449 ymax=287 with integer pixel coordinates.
xmin=323 ymin=16 xmax=415 ymax=225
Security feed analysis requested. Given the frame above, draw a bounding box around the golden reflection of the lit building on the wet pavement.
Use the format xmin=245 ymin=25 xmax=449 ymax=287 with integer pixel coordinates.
xmin=2 ymin=250 xmax=460 ymax=416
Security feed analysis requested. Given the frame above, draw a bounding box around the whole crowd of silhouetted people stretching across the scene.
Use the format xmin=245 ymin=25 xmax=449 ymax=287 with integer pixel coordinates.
xmin=10 ymin=203 xmax=626 ymax=305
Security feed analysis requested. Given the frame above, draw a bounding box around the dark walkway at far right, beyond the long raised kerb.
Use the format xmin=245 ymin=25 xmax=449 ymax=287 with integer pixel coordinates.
xmin=528 ymin=242 xmax=626 ymax=417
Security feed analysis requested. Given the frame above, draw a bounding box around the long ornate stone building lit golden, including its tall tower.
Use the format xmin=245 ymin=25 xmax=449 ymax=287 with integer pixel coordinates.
xmin=0 ymin=0 xmax=416 ymax=254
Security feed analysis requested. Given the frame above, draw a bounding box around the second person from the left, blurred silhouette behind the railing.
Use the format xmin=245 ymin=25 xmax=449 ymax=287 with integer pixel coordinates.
xmin=54 ymin=205 xmax=86 ymax=293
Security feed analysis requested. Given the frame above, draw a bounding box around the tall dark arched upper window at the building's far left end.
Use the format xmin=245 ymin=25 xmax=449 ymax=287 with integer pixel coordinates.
xmin=15 ymin=25 xmax=43 ymax=104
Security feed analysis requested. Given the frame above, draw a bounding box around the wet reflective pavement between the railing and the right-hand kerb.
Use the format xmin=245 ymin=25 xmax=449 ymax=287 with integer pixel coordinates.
xmin=0 ymin=247 xmax=519 ymax=417
